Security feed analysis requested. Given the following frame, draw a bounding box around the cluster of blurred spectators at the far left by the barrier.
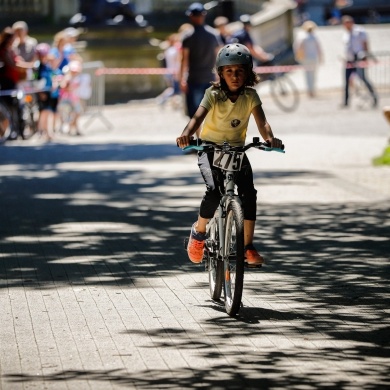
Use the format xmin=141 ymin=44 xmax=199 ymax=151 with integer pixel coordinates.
xmin=0 ymin=21 xmax=89 ymax=141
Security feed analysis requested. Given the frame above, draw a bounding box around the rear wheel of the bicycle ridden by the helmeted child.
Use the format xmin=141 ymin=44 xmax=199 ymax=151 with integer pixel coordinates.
xmin=207 ymin=215 xmax=223 ymax=301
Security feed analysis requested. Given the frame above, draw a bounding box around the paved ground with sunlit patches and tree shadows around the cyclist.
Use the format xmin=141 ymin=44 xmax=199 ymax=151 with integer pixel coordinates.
xmin=0 ymin=27 xmax=390 ymax=390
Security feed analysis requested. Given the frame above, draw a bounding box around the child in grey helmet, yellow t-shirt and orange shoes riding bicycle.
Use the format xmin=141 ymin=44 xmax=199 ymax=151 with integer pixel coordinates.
xmin=176 ymin=43 xmax=282 ymax=265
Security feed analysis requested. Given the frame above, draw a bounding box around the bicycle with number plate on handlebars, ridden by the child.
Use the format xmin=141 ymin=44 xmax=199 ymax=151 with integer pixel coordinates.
xmin=183 ymin=137 xmax=284 ymax=317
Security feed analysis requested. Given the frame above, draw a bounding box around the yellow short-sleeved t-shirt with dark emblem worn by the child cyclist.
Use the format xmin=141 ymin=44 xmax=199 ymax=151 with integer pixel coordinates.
xmin=200 ymin=87 xmax=262 ymax=146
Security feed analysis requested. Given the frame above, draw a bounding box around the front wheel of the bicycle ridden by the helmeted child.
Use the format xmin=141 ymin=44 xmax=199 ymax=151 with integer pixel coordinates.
xmin=224 ymin=199 xmax=244 ymax=317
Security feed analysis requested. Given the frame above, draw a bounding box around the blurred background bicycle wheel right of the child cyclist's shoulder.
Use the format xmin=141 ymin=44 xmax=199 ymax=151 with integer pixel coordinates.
xmin=270 ymin=75 xmax=299 ymax=112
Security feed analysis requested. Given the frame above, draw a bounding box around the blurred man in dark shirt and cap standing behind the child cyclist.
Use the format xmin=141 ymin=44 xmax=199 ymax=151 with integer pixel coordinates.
xmin=180 ymin=3 xmax=222 ymax=118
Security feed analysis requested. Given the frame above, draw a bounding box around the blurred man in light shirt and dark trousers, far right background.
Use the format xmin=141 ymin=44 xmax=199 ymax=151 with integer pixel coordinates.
xmin=341 ymin=15 xmax=378 ymax=107
